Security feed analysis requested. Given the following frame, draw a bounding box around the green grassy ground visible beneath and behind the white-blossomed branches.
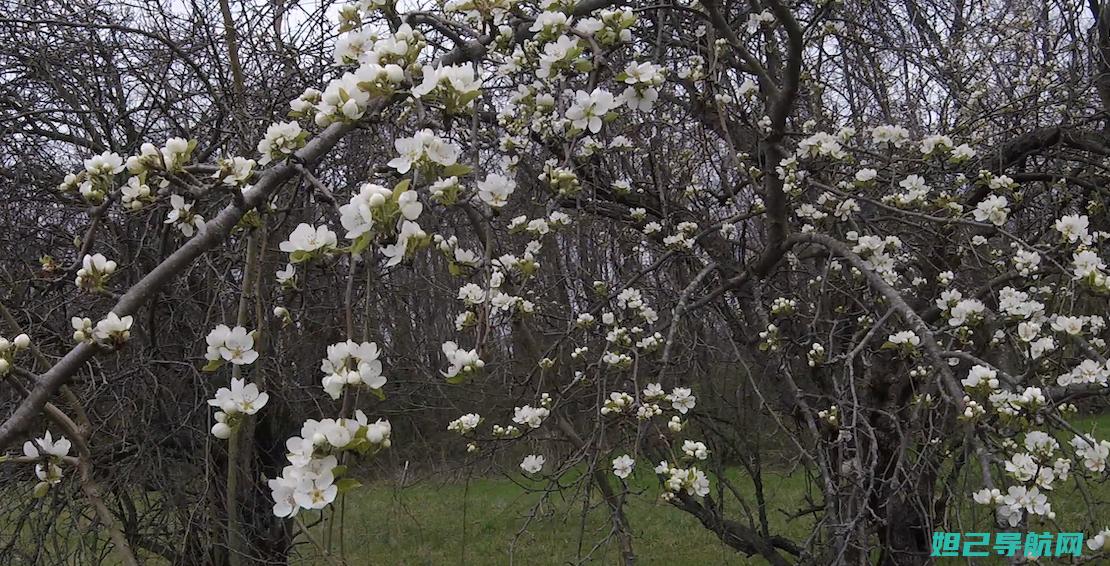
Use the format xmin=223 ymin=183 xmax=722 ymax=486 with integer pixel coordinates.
xmin=290 ymin=415 xmax=1110 ymax=566
